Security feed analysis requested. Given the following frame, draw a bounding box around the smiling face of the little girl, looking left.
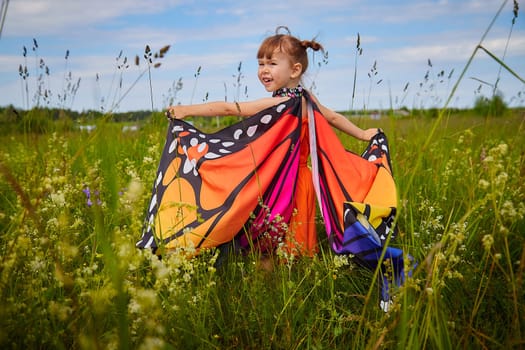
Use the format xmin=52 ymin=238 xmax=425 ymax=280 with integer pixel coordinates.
xmin=257 ymin=50 xmax=301 ymax=92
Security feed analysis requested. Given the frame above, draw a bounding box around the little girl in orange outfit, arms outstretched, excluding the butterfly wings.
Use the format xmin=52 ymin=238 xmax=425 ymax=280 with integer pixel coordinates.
xmin=163 ymin=27 xmax=378 ymax=256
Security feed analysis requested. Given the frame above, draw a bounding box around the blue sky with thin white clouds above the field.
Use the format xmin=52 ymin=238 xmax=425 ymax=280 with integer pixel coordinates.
xmin=0 ymin=0 xmax=525 ymax=111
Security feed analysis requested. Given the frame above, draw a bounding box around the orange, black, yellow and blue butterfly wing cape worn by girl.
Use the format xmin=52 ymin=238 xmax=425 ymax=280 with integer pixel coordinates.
xmin=137 ymin=92 xmax=412 ymax=300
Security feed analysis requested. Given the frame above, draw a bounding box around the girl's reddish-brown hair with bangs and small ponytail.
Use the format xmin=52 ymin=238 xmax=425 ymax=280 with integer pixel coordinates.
xmin=257 ymin=26 xmax=324 ymax=73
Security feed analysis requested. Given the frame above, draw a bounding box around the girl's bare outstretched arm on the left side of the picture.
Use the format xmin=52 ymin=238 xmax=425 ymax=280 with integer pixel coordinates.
xmin=167 ymin=97 xmax=288 ymax=119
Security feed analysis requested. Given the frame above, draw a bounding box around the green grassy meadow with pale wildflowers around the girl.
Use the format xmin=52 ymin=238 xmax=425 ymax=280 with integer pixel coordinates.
xmin=0 ymin=105 xmax=525 ymax=349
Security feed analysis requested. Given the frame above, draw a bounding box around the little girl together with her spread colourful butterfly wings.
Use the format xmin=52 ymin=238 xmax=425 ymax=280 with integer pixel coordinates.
xmin=137 ymin=28 xmax=411 ymax=310
